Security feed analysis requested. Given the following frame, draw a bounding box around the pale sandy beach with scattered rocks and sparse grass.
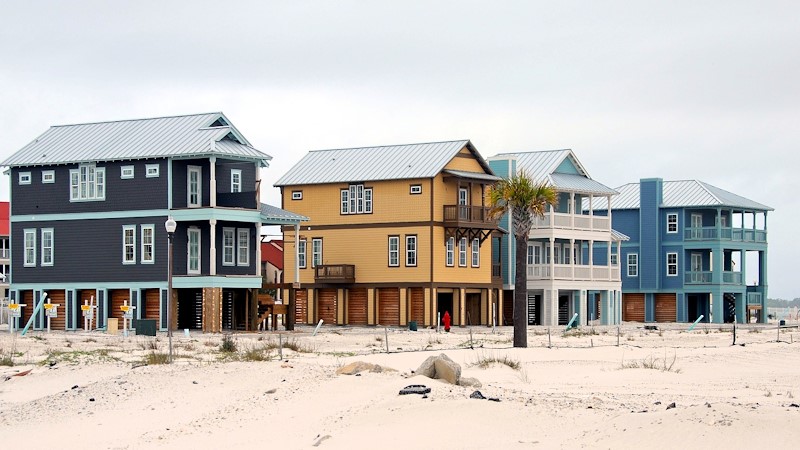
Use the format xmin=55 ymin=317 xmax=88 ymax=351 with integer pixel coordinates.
xmin=0 ymin=324 xmax=800 ymax=449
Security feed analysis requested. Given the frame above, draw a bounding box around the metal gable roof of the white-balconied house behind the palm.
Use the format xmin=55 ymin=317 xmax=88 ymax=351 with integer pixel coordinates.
xmin=489 ymin=149 xmax=617 ymax=195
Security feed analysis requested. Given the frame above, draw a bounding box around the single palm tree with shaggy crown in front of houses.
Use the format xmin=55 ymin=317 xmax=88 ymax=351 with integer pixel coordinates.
xmin=489 ymin=170 xmax=558 ymax=347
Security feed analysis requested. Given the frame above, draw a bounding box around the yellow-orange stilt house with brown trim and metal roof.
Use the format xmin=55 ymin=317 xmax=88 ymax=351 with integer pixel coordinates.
xmin=275 ymin=140 xmax=502 ymax=326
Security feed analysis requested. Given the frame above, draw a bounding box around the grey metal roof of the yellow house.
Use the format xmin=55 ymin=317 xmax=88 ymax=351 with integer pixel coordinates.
xmin=275 ymin=140 xmax=493 ymax=186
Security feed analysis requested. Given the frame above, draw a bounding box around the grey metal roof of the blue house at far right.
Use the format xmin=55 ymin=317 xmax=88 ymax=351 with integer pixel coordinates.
xmin=593 ymin=180 xmax=773 ymax=211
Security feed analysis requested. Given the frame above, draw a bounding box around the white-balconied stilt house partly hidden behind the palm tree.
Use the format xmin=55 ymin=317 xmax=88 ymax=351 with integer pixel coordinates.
xmin=488 ymin=150 xmax=626 ymax=325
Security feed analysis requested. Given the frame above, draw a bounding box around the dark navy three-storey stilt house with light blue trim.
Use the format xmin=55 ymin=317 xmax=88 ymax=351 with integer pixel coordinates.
xmin=2 ymin=113 xmax=302 ymax=332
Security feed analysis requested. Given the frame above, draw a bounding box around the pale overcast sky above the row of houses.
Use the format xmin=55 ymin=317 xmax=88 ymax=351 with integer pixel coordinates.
xmin=0 ymin=0 xmax=800 ymax=298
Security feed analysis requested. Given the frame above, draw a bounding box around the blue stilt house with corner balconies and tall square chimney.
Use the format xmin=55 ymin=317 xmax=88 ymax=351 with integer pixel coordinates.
xmin=597 ymin=178 xmax=772 ymax=323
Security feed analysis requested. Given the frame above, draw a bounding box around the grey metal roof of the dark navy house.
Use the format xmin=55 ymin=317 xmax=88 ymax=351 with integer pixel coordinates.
xmin=0 ymin=112 xmax=272 ymax=167
